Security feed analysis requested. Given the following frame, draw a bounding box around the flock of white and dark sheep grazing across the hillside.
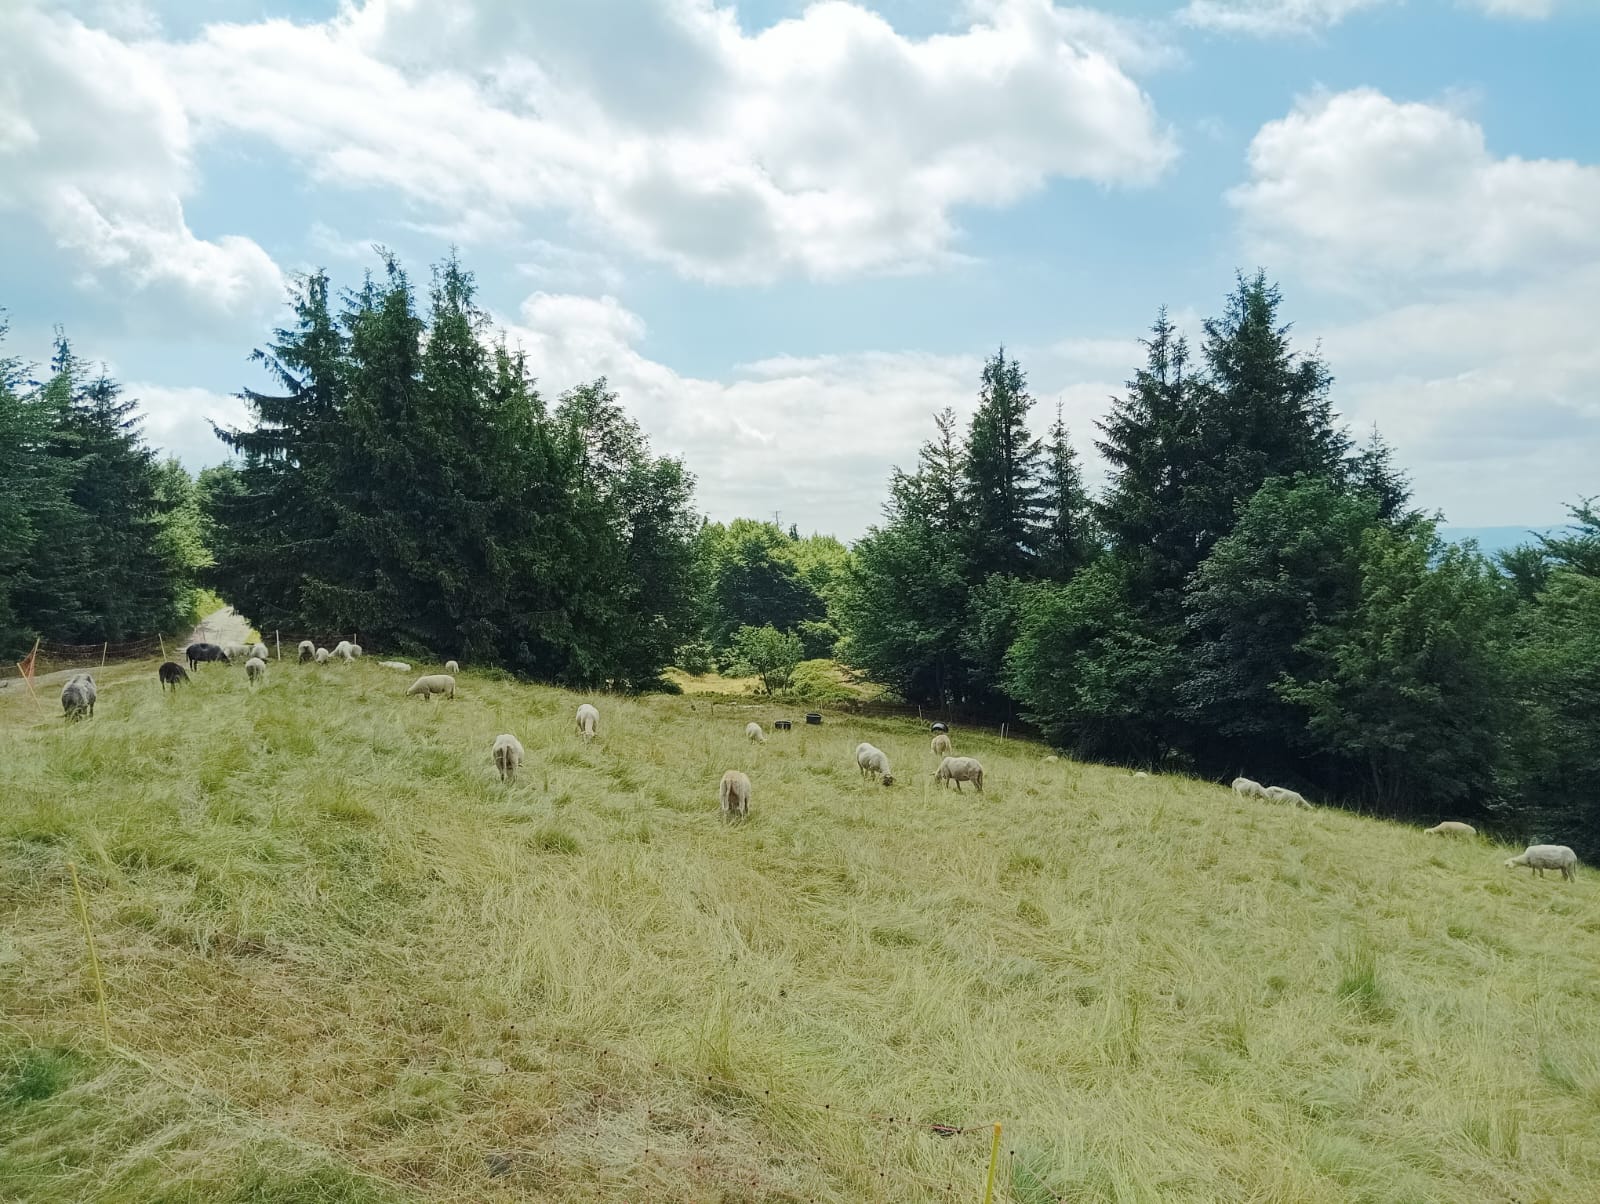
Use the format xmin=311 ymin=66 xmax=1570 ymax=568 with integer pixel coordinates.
xmin=50 ymin=640 xmax=1578 ymax=882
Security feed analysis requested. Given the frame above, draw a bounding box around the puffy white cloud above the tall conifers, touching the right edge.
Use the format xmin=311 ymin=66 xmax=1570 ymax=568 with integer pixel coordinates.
xmin=1229 ymin=88 xmax=1600 ymax=283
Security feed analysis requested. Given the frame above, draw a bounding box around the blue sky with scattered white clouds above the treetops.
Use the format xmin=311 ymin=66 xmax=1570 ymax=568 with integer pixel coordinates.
xmin=0 ymin=0 xmax=1600 ymax=538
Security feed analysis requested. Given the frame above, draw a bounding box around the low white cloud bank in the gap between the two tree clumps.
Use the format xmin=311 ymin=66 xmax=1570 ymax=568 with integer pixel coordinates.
xmin=509 ymin=293 xmax=1138 ymax=538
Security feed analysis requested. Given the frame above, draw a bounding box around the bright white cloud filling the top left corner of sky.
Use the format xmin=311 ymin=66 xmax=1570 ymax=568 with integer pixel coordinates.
xmin=0 ymin=5 xmax=283 ymax=314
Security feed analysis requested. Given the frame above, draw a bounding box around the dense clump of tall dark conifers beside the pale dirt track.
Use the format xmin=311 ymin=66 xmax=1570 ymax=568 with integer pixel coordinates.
xmin=200 ymin=256 xmax=698 ymax=688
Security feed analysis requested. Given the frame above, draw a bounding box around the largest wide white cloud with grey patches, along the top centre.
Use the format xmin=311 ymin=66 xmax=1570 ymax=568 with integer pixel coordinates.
xmin=152 ymin=0 xmax=1174 ymax=282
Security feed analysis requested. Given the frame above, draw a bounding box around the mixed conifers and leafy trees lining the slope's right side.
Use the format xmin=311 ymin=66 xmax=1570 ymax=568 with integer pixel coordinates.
xmin=838 ymin=274 xmax=1600 ymax=855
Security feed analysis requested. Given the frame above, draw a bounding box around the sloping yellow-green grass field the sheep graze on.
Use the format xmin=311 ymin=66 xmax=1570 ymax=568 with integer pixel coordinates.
xmin=0 ymin=660 xmax=1600 ymax=1204
